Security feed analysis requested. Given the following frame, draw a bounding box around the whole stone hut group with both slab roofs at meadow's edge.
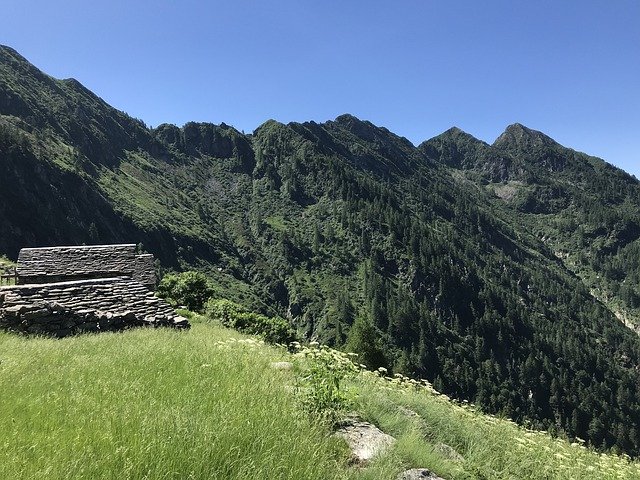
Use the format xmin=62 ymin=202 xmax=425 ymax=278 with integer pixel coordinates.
xmin=0 ymin=244 xmax=189 ymax=337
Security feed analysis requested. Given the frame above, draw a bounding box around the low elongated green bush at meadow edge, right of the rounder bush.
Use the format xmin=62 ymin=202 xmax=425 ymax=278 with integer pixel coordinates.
xmin=205 ymin=299 xmax=296 ymax=345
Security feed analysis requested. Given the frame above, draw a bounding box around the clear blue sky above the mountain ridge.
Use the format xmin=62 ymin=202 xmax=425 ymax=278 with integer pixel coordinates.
xmin=0 ymin=0 xmax=640 ymax=177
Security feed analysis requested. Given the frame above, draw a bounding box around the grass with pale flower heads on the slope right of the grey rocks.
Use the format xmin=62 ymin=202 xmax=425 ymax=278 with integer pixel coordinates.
xmin=350 ymin=372 xmax=640 ymax=480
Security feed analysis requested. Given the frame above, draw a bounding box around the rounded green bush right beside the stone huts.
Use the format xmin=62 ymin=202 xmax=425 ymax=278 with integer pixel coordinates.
xmin=157 ymin=271 xmax=214 ymax=312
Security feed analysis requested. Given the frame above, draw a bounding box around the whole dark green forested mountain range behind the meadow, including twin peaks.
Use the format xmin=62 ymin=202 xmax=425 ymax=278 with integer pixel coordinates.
xmin=0 ymin=47 xmax=640 ymax=454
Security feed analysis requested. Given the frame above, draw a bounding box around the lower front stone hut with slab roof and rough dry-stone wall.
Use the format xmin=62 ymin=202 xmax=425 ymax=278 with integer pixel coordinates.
xmin=0 ymin=277 xmax=189 ymax=337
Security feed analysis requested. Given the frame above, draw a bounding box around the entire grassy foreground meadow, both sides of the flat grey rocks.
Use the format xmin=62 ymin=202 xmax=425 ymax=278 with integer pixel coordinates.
xmin=0 ymin=323 xmax=640 ymax=480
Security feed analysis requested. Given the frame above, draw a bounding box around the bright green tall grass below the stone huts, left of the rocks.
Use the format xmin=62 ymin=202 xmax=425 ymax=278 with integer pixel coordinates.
xmin=0 ymin=324 xmax=347 ymax=479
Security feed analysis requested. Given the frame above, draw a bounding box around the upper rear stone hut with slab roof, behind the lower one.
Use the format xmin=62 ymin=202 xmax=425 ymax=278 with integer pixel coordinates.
xmin=16 ymin=244 xmax=156 ymax=289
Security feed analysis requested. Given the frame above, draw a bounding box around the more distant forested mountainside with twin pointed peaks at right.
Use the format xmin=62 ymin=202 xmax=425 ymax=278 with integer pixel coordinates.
xmin=419 ymin=124 xmax=640 ymax=329
